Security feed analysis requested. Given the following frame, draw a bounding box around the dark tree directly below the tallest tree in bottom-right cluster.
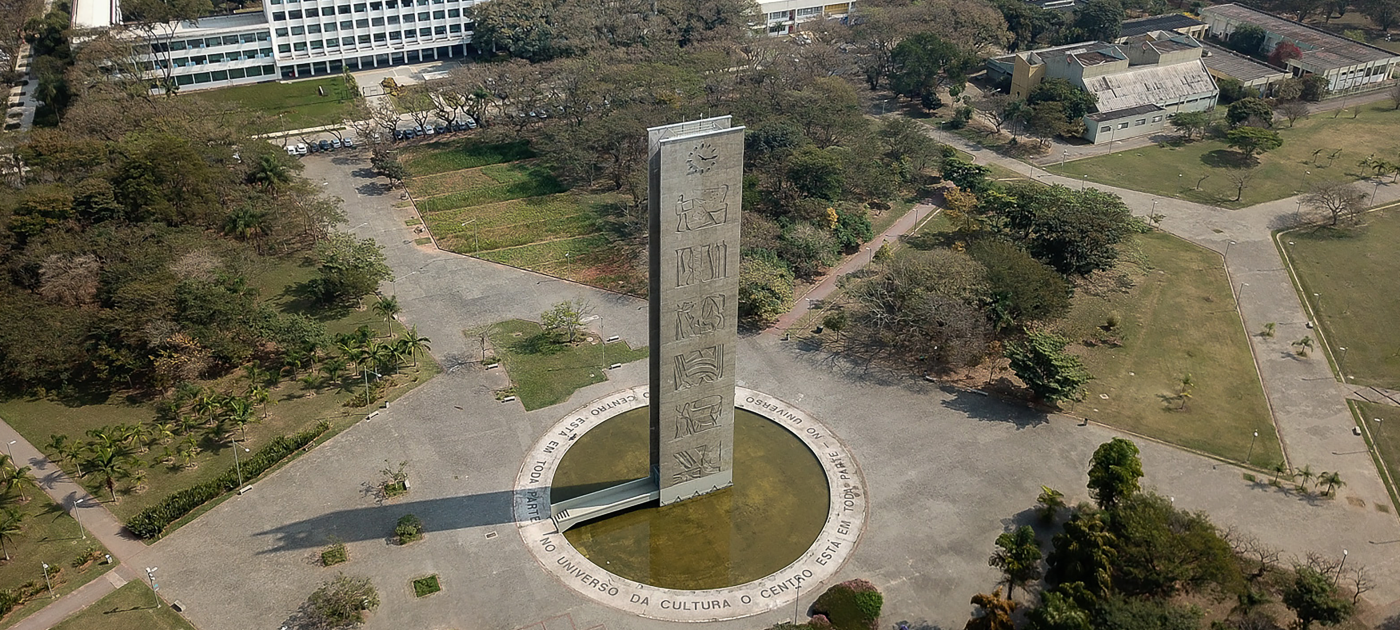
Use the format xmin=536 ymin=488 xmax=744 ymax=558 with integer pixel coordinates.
xmin=1046 ymin=510 xmax=1117 ymax=599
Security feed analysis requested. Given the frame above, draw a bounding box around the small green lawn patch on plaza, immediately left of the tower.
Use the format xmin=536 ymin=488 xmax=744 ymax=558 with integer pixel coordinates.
xmin=487 ymin=319 xmax=647 ymax=410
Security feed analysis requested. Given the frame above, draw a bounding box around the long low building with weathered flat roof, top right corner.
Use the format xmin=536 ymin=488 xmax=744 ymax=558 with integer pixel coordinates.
xmin=1201 ymin=4 xmax=1400 ymax=91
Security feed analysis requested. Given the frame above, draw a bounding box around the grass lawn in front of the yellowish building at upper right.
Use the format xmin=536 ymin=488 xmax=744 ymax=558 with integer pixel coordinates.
xmin=1050 ymin=101 xmax=1400 ymax=207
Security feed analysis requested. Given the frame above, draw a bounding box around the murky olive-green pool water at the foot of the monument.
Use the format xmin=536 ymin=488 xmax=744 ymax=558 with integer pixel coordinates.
xmin=550 ymin=407 xmax=829 ymax=591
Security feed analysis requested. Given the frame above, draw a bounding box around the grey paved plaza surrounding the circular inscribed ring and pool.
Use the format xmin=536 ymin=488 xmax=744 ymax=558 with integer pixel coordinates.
xmin=117 ymin=154 xmax=1400 ymax=630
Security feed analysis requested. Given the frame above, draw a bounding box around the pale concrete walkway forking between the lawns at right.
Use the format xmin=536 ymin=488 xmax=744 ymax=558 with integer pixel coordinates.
xmin=930 ymin=119 xmax=1400 ymax=518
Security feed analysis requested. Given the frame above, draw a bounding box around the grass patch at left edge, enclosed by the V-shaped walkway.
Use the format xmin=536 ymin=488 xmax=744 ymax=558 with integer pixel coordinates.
xmin=0 ymin=492 xmax=115 ymax=627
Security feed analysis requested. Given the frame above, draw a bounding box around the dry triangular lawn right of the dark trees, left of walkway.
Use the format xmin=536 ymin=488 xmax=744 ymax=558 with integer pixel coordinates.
xmin=1057 ymin=232 xmax=1280 ymax=468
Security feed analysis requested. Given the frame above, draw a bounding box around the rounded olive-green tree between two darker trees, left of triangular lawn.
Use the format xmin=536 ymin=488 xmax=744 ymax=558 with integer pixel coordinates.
xmin=967 ymin=239 xmax=1072 ymax=329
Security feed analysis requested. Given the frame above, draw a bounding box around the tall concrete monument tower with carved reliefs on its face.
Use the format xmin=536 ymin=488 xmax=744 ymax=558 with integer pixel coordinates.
xmin=647 ymin=116 xmax=743 ymax=505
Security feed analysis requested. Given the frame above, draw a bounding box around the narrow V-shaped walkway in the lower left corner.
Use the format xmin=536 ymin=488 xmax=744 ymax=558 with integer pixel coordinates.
xmin=0 ymin=421 xmax=157 ymax=630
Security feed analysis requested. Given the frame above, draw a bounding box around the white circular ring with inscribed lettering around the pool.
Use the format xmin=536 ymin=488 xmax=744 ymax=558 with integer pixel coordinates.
xmin=514 ymin=386 xmax=869 ymax=622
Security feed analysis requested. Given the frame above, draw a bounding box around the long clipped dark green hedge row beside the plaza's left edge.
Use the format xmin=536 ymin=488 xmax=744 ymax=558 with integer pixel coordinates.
xmin=126 ymin=420 xmax=330 ymax=539
